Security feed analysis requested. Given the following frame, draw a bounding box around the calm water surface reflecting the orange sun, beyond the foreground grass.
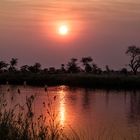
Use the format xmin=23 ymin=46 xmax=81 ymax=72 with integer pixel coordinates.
xmin=0 ymin=86 xmax=140 ymax=140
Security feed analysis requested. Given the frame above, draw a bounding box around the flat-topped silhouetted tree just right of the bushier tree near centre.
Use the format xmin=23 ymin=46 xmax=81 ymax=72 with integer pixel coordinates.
xmin=81 ymin=57 xmax=93 ymax=72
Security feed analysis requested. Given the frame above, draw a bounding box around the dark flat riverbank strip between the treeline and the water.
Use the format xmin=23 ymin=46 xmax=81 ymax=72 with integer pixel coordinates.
xmin=0 ymin=73 xmax=140 ymax=89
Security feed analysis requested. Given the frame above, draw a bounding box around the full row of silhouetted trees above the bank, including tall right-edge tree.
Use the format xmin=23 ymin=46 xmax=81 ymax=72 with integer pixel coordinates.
xmin=0 ymin=45 xmax=140 ymax=75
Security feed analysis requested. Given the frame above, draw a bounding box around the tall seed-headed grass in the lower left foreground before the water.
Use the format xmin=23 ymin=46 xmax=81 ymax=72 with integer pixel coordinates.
xmin=0 ymin=92 xmax=67 ymax=140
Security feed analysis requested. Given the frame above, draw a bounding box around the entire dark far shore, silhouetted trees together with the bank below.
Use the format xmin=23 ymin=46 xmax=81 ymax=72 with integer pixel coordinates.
xmin=0 ymin=46 xmax=140 ymax=89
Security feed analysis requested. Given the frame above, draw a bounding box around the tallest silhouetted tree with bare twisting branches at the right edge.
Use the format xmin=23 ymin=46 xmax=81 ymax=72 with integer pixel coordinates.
xmin=126 ymin=46 xmax=140 ymax=75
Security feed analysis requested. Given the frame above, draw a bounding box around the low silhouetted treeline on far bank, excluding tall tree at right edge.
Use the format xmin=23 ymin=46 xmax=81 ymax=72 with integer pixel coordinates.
xmin=0 ymin=57 xmax=127 ymax=75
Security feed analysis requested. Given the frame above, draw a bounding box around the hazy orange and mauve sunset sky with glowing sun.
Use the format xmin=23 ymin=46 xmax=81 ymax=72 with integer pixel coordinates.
xmin=0 ymin=0 xmax=140 ymax=69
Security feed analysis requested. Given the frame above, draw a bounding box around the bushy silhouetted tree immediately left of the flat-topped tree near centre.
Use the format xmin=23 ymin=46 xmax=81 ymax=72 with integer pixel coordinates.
xmin=67 ymin=58 xmax=79 ymax=73
